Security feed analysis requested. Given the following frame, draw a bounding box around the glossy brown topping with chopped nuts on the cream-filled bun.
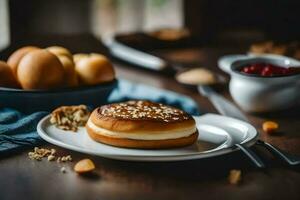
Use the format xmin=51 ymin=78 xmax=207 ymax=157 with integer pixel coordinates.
xmin=98 ymin=101 xmax=190 ymax=122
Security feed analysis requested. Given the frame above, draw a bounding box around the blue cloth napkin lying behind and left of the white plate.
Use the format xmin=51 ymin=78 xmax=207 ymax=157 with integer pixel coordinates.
xmin=0 ymin=80 xmax=199 ymax=152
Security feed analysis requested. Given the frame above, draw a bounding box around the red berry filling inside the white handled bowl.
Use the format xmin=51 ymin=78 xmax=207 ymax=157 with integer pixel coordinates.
xmin=239 ymin=63 xmax=300 ymax=77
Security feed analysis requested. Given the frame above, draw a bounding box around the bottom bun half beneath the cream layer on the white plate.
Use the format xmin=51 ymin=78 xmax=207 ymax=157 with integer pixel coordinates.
xmin=86 ymin=125 xmax=198 ymax=149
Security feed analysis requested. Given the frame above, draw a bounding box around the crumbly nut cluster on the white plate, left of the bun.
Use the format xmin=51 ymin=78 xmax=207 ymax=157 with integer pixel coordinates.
xmin=50 ymin=105 xmax=90 ymax=131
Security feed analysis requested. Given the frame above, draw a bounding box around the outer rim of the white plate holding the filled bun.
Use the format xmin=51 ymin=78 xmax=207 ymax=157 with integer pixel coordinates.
xmin=37 ymin=113 xmax=259 ymax=162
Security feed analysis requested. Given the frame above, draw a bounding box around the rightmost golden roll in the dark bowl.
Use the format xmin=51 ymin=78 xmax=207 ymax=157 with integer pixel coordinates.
xmin=75 ymin=53 xmax=115 ymax=85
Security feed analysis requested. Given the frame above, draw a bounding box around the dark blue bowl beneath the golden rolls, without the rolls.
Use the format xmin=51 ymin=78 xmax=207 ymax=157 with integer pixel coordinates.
xmin=0 ymin=80 xmax=118 ymax=113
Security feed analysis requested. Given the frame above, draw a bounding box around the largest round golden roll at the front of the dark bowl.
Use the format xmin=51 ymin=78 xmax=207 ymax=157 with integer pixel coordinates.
xmin=17 ymin=50 xmax=65 ymax=89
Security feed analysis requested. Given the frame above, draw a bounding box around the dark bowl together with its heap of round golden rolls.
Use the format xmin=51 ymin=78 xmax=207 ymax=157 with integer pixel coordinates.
xmin=0 ymin=46 xmax=117 ymax=112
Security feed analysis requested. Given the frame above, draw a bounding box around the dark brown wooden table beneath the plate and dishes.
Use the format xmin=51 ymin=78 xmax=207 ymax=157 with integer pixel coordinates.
xmin=0 ymin=34 xmax=300 ymax=200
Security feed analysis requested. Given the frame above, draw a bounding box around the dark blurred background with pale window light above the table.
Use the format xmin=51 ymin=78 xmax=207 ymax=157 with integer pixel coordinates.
xmin=0 ymin=0 xmax=300 ymax=50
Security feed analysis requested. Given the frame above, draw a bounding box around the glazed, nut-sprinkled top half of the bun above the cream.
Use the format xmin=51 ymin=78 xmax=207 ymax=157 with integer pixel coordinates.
xmin=90 ymin=101 xmax=195 ymax=133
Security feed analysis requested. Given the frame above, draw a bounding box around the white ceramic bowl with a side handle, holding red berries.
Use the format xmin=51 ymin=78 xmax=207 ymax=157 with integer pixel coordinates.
xmin=218 ymin=54 xmax=300 ymax=112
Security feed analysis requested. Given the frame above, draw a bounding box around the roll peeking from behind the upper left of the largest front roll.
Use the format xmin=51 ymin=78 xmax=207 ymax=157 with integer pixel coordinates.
xmin=7 ymin=46 xmax=40 ymax=77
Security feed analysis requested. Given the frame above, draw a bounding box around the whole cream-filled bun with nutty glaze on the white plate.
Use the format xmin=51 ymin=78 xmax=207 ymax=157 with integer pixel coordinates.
xmin=86 ymin=101 xmax=198 ymax=149
